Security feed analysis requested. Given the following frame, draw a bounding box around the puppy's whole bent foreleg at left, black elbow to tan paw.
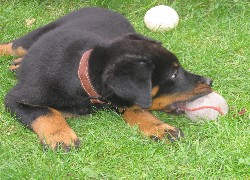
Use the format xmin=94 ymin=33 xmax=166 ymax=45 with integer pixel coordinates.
xmin=5 ymin=94 xmax=80 ymax=151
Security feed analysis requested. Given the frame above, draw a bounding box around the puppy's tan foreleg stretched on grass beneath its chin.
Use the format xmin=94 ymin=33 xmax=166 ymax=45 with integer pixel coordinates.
xmin=122 ymin=109 xmax=184 ymax=142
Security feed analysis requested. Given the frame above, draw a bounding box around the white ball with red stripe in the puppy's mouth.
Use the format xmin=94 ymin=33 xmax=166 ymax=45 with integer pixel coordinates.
xmin=185 ymin=92 xmax=228 ymax=122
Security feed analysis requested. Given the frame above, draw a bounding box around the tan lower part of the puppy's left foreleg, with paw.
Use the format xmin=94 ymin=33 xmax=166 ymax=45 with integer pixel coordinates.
xmin=31 ymin=109 xmax=79 ymax=149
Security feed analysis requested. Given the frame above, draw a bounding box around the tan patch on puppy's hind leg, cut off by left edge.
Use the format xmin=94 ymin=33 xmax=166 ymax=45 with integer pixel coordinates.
xmin=0 ymin=43 xmax=27 ymax=57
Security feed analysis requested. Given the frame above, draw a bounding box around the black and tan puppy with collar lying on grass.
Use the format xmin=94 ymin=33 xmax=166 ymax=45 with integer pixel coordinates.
xmin=0 ymin=8 xmax=212 ymax=149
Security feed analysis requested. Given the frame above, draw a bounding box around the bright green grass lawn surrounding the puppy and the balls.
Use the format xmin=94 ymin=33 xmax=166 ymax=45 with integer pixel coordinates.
xmin=0 ymin=0 xmax=250 ymax=179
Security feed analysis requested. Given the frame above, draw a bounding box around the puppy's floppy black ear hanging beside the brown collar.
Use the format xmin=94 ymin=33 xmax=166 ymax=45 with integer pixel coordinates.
xmin=103 ymin=60 xmax=153 ymax=108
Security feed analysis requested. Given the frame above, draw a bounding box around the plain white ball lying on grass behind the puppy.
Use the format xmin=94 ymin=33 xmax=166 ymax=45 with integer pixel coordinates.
xmin=144 ymin=5 xmax=179 ymax=32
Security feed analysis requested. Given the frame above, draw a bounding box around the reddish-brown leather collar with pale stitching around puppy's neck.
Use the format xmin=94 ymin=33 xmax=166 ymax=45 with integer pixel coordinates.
xmin=78 ymin=49 xmax=104 ymax=104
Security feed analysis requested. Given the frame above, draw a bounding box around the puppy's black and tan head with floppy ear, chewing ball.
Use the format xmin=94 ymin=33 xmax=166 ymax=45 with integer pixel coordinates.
xmin=100 ymin=35 xmax=212 ymax=111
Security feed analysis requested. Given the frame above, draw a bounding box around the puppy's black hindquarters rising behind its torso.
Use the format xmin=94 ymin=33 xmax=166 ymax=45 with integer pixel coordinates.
xmin=12 ymin=7 xmax=135 ymax=51
